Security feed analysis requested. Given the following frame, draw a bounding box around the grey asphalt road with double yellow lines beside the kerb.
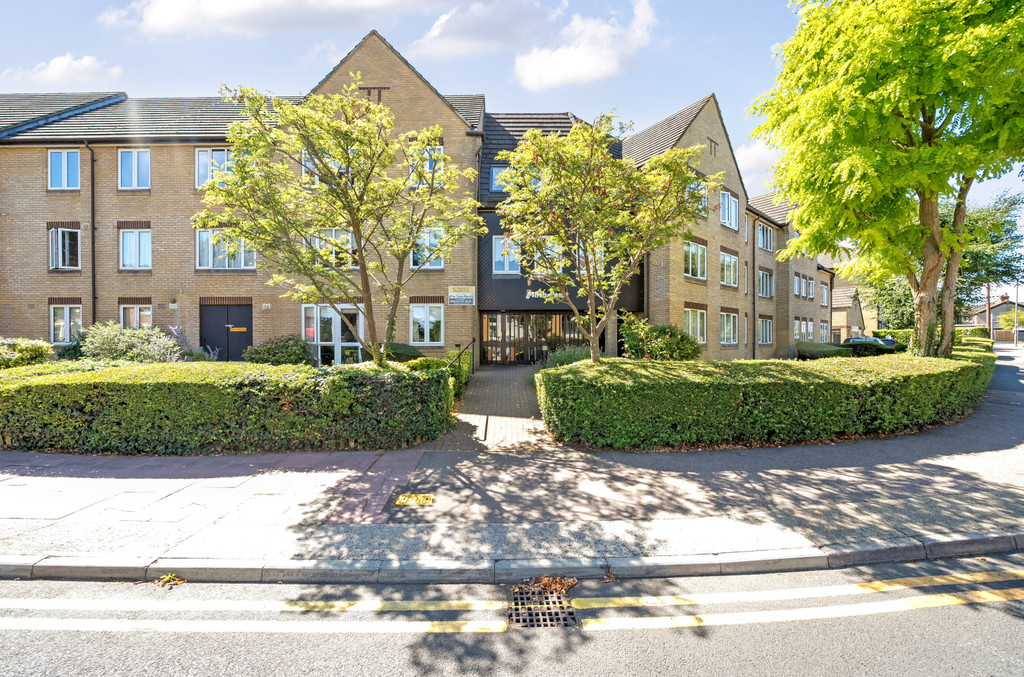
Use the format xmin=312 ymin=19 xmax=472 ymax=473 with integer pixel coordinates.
xmin=0 ymin=553 xmax=1024 ymax=677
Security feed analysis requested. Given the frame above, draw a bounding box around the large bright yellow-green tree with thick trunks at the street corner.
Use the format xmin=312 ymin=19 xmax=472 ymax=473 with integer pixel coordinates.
xmin=753 ymin=0 xmax=1024 ymax=354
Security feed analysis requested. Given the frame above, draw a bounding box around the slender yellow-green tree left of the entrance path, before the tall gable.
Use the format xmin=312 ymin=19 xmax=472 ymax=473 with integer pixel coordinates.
xmin=195 ymin=82 xmax=480 ymax=363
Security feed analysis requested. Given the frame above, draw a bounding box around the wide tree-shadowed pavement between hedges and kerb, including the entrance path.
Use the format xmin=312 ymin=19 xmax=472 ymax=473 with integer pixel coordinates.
xmin=0 ymin=346 xmax=1024 ymax=583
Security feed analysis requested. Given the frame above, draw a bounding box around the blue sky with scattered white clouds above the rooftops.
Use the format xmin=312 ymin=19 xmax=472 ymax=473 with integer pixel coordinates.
xmin=6 ymin=0 xmax=1024 ymax=280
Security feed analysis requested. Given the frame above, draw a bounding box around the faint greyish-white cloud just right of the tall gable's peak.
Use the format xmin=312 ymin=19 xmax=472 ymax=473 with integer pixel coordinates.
xmin=410 ymin=0 xmax=568 ymax=58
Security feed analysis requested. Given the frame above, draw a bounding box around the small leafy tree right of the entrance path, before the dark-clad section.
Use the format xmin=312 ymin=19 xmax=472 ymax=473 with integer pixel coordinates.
xmin=498 ymin=115 xmax=715 ymax=363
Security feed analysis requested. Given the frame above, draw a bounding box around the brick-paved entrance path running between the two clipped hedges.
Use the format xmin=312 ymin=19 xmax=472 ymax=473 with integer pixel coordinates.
xmin=416 ymin=367 xmax=564 ymax=452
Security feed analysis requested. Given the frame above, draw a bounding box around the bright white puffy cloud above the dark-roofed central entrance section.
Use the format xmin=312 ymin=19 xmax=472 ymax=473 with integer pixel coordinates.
xmin=515 ymin=0 xmax=657 ymax=91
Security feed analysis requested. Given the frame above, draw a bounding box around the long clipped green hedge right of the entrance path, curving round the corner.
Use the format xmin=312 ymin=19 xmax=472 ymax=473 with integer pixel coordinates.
xmin=536 ymin=339 xmax=995 ymax=449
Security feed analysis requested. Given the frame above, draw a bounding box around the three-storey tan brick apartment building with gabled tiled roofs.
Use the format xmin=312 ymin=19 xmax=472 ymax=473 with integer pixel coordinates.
xmin=0 ymin=32 xmax=830 ymax=364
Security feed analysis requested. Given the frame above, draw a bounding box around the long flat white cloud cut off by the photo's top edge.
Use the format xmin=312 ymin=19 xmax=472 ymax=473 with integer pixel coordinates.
xmin=97 ymin=0 xmax=438 ymax=37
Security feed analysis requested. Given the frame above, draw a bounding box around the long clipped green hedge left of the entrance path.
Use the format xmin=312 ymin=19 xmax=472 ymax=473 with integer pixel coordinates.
xmin=0 ymin=361 xmax=453 ymax=454
